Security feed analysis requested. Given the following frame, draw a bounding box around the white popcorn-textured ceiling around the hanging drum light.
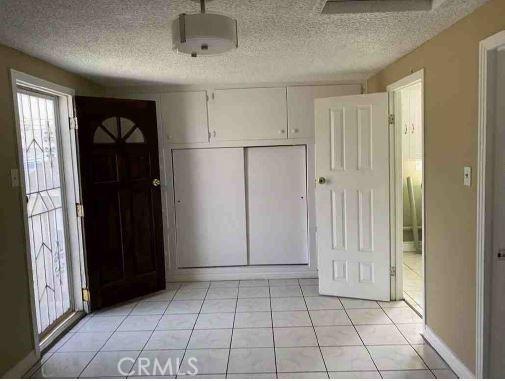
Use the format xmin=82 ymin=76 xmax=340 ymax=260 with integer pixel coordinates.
xmin=0 ymin=0 xmax=486 ymax=86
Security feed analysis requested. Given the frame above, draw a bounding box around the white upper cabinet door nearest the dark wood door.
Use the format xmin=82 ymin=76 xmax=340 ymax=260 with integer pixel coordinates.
xmin=160 ymin=91 xmax=209 ymax=143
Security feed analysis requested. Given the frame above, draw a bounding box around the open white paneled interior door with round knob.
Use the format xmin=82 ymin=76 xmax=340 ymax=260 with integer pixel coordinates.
xmin=315 ymin=93 xmax=390 ymax=300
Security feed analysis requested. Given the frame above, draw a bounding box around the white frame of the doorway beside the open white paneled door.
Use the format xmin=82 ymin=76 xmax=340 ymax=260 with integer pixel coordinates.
xmin=387 ymin=69 xmax=426 ymax=323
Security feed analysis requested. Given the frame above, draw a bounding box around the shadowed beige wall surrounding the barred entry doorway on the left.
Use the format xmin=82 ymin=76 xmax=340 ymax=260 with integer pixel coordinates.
xmin=0 ymin=45 xmax=100 ymax=375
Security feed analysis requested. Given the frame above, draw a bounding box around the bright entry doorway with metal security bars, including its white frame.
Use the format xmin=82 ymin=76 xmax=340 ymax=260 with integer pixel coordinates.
xmin=11 ymin=70 xmax=85 ymax=354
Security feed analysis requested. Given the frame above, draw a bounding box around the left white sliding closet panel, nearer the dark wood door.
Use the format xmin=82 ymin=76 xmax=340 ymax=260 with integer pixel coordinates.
xmin=173 ymin=148 xmax=247 ymax=267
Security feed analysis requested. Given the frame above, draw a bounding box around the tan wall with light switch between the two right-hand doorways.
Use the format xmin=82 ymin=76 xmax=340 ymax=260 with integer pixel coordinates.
xmin=368 ymin=0 xmax=505 ymax=370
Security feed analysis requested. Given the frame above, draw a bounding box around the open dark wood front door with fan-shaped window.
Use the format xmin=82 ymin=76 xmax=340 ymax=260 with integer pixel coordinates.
xmin=76 ymin=97 xmax=165 ymax=310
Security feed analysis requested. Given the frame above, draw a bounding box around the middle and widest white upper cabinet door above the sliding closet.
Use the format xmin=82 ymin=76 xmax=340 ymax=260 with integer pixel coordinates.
xmin=209 ymin=88 xmax=287 ymax=141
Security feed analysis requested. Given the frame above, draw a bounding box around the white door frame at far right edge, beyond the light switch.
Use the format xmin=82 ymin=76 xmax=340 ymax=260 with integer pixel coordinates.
xmin=475 ymin=31 xmax=505 ymax=378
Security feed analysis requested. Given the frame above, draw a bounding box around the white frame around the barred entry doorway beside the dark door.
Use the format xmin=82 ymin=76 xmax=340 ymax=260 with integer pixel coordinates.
xmin=10 ymin=69 xmax=88 ymax=359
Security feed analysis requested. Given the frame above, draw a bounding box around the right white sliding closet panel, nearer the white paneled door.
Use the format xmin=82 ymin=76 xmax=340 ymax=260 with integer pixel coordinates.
xmin=246 ymin=146 xmax=308 ymax=265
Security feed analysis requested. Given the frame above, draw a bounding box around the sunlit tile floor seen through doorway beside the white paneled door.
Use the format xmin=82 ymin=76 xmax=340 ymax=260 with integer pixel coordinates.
xmin=403 ymin=252 xmax=424 ymax=314
